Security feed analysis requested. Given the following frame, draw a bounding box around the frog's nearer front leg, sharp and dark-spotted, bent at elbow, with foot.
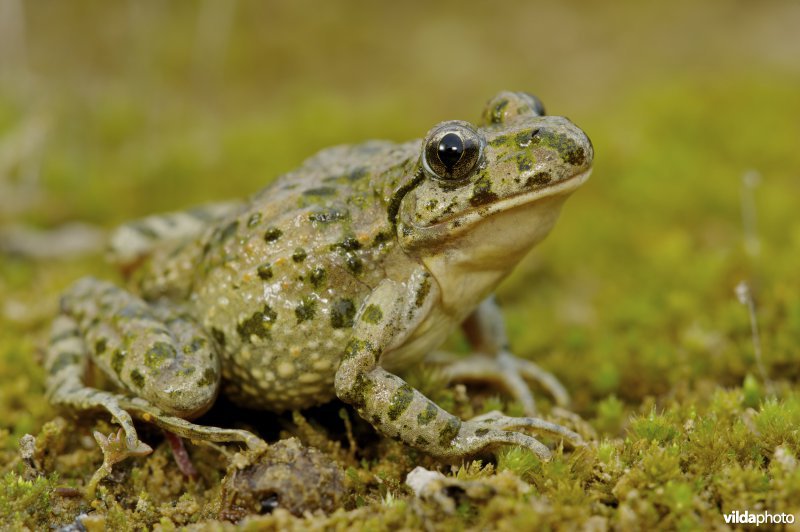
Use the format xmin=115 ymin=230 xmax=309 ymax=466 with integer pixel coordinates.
xmin=336 ymin=271 xmax=582 ymax=460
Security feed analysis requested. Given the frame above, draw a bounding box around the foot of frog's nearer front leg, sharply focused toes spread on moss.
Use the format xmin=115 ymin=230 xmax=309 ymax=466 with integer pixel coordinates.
xmin=452 ymin=410 xmax=584 ymax=460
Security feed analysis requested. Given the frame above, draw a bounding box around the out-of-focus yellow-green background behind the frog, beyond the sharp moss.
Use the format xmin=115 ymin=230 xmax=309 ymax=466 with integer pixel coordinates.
xmin=0 ymin=0 xmax=800 ymax=528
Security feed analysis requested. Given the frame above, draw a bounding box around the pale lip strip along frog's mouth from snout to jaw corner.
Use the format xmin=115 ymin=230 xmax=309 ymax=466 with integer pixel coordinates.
xmin=397 ymin=168 xmax=592 ymax=252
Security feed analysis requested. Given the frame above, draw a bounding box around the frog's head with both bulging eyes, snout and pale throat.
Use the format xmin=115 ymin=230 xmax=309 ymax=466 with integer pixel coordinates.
xmin=396 ymin=92 xmax=594 ymax=304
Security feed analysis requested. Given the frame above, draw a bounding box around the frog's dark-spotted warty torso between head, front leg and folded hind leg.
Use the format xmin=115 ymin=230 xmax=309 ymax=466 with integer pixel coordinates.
xmin=191 ymin=142 xmax=417 ymax=410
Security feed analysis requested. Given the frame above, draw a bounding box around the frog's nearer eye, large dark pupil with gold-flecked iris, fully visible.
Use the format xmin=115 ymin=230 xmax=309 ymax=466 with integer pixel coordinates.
xmin=422 ymin=122 xmax=484 ymax=181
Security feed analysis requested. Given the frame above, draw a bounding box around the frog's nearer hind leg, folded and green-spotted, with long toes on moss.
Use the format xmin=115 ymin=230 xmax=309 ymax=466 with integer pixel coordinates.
xmin=45 ymin=278 xmax=263 ymax=454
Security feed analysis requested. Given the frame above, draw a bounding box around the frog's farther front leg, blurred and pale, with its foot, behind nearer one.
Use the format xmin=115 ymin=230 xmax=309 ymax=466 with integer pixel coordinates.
xmin=431 ymin=296 xmax=570 ymax=415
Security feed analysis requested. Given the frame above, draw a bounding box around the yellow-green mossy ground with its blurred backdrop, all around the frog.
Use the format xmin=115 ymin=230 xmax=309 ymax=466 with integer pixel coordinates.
xmin=0 ymin=1 xmax=800 ymax=530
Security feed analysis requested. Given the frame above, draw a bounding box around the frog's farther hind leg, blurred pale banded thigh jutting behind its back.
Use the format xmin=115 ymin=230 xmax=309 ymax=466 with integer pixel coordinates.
xmin=109 ymin=201 xmax=243 ymax=267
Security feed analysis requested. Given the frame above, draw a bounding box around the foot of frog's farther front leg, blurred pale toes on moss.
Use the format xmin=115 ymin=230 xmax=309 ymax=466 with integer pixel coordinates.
xmin=429 ymin=351 xmax=570 ymax=416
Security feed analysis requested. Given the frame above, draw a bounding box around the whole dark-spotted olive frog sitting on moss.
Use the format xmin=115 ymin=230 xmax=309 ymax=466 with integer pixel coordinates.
xmin=45 ymin=91 xmax=594 ymax=470
